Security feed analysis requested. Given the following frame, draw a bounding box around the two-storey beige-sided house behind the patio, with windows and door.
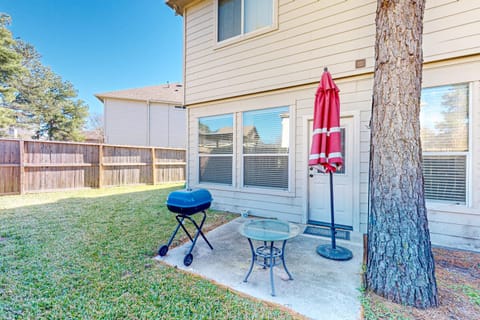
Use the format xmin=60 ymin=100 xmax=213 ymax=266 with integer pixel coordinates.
xmin=167 ymin=0 xmax=480 ymax=250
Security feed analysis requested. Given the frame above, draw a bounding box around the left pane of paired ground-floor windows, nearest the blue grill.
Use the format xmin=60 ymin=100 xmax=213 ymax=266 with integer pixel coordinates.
xmin=198 ymin=114 xmax=234 ymax=185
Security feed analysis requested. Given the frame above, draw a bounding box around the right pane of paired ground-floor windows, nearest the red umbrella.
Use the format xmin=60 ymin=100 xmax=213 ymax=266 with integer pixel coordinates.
xmin=243 ymin=107 xmax=290 ymax=190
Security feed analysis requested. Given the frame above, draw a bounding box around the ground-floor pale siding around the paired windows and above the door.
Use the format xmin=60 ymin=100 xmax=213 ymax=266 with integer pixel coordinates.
xmin=189 ymin=77 xmax=372 ymax=224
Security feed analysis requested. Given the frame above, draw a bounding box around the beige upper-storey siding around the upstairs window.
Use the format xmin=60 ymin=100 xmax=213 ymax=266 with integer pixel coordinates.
xmin=185 ymin=0 xmax=480 ymax=104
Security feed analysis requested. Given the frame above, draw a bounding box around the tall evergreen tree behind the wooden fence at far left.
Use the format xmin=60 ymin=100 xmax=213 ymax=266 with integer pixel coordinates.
xmin=0 ymin=16 xmax=88 ymax=141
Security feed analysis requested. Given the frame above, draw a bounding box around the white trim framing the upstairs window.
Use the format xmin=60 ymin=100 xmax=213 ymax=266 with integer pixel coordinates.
xmin=213 ymin=0 xmax=278 ymax=49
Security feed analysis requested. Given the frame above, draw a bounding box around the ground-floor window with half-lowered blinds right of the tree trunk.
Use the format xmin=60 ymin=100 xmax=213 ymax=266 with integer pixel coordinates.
xmin=420 ymin=84 xmax=470 ymax=204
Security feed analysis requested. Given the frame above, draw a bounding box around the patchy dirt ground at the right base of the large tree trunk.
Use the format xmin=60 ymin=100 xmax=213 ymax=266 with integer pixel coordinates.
xmin=364 ymin=248 xmax=480 ymax=320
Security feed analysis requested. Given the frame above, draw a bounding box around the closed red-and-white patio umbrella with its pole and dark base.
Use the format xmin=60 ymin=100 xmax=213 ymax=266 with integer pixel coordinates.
xmin=308 ymin=68 xmax=352 ymax=260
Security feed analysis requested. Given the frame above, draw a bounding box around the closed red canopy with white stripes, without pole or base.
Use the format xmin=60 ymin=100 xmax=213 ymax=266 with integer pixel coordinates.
xmin=308 ymin=71 xmax=343 ymax=172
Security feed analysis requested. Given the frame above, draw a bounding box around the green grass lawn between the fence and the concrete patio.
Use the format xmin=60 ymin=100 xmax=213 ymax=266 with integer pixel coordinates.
xmin=0 ymin=185 xmax=298 ymax=319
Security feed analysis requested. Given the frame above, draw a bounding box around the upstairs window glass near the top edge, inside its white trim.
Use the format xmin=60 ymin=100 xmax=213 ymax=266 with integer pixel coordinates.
xmin=217 ymin=0 xmax=276 ymax=42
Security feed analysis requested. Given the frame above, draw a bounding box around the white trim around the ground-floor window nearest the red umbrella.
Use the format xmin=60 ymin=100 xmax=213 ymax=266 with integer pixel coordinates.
xmin=238 ymin=105 xmax=295 ymax=197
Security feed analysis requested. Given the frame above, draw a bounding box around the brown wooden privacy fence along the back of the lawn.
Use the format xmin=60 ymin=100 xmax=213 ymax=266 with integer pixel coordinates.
xmin=0 ymin=139 xmax=186 ymax=195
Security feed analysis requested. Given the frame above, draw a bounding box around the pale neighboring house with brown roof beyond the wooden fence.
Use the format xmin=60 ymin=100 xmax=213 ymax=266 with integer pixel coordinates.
xmin=95 ymin=83 xmax=187 ymax=148
